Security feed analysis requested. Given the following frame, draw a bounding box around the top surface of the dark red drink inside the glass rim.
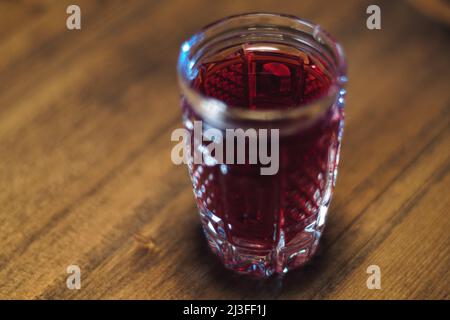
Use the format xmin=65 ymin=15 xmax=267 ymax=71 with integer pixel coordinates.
xmin=193 ymin=44 xmax=331 ymax=109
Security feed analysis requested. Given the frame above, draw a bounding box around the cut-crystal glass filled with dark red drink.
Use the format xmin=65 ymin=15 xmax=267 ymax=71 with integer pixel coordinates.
xmin=178 ymin=13 xmax=347 ymax=277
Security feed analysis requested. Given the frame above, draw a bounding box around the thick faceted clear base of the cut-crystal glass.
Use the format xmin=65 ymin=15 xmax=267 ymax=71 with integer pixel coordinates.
xmin=200 ymin=208 xmax=327 ymax=278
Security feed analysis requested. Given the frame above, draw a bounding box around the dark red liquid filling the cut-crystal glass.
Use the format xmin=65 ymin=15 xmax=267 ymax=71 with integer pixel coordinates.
xmin=183 ymin=46 xmax=343 ymax=276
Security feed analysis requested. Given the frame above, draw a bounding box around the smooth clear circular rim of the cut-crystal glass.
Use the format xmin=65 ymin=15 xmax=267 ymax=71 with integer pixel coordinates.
xmin=177 ymin=12 xmax=347 ymax=127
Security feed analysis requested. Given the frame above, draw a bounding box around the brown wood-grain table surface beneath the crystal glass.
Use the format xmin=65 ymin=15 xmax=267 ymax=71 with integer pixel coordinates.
xmin=0 ymin=0 xmax=450 ymax=299
